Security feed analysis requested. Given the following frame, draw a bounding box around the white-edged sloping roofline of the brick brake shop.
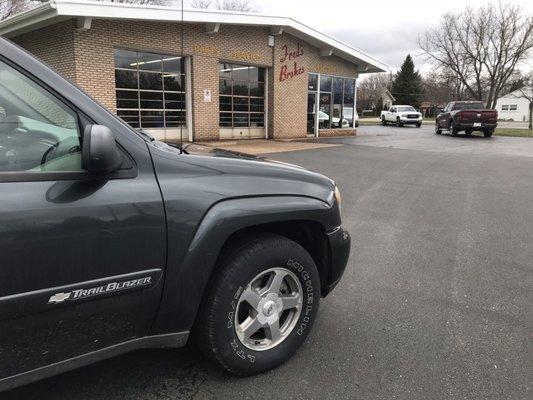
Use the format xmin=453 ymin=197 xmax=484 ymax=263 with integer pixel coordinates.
xmin=0 ymin=0 xmax=390 ymax=73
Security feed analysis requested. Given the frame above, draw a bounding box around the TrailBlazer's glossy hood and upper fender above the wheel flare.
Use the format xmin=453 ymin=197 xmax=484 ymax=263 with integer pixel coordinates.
xmin=147 ymin=141 xmax=335 ymax=205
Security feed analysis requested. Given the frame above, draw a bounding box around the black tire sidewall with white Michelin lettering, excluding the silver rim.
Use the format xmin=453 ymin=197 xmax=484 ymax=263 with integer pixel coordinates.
xmin=211 ymin=242 xmax=320 ymax=375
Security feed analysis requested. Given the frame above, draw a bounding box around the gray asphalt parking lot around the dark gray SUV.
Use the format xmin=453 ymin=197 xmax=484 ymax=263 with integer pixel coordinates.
xmin=5 ymin=126 xmax=533 ymax=400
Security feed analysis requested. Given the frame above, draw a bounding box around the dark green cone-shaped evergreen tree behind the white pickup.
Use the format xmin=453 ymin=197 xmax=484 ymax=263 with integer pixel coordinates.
xmin=391 ymin=54 xmax=422 ymax=108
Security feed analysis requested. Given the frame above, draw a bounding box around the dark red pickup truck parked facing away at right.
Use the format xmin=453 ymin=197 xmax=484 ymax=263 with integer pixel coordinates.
xmin=435 ymin=101 xmax=498 ymax=137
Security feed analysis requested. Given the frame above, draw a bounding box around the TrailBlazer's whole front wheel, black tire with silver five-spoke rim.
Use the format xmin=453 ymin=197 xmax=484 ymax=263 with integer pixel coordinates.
xmin=194 ymin=234 xmax=320 ymax=375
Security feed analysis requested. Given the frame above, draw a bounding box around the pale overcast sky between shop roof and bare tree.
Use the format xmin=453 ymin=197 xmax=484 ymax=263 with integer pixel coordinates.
xmin=188 ymin=0 xmax=533 ymax=71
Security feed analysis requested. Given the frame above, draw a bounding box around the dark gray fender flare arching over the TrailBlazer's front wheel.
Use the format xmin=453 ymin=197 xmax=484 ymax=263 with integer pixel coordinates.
xmin=151 ymin=196 xmax=341 ymax=334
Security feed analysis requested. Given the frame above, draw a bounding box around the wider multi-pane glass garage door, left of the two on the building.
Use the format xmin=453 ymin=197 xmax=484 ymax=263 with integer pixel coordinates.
xmin=115 ymin=49 xmax=186 ymax=128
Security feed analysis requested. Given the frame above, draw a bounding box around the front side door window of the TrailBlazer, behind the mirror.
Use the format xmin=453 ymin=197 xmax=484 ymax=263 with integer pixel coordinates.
xmin=0 ymin=61 xmax=82 ymax=175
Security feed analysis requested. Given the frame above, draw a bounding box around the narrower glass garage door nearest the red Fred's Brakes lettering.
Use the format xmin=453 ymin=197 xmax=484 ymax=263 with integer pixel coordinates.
xmin=219 ymin=62 xmax=265 ymax=128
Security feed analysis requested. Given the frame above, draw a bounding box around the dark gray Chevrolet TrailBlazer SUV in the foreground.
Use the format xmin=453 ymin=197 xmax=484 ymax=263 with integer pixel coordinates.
xmin=0 ymin=39 xmax=350 ymax=391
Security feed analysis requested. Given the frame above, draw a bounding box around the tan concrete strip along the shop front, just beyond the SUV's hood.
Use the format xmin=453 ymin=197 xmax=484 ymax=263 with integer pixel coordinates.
xmin=193 ymin=139 xmax=339 ymax=155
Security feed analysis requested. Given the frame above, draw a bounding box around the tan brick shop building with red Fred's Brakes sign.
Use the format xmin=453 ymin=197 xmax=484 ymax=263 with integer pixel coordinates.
xmin=0 ymin=0 xmax=388 ymax=141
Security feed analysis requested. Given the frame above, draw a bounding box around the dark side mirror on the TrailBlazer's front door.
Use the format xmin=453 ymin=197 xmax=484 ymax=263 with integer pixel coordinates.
xmin=81 ymin=125 xmax=122 ymax=175
